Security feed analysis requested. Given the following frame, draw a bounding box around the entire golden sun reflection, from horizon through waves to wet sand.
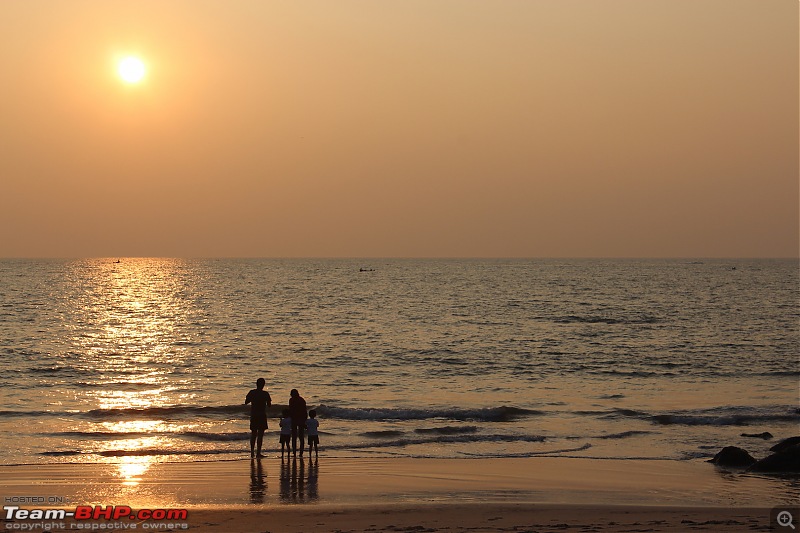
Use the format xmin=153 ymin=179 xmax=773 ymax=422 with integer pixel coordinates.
xmin=55 ymin=259 xmax=212 ymax=476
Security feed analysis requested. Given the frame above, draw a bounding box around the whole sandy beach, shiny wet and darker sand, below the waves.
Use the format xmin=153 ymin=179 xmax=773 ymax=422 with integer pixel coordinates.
xmin=0 ymin=457 xmax=800 ymax=533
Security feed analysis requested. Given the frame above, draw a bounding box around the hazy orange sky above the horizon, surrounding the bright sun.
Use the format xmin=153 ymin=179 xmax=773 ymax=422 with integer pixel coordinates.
xmin=0 ymin=0 xmax=800 ymax=257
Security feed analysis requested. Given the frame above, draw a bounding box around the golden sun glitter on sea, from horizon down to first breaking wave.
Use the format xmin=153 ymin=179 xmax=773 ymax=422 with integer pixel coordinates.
xmin=62 ymin=259 xmax=205 ymax=409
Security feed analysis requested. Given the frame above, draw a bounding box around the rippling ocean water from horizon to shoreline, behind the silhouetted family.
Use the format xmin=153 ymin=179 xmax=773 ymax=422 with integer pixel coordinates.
xmin=0 ymin=259 xmax=800 ymax=475
